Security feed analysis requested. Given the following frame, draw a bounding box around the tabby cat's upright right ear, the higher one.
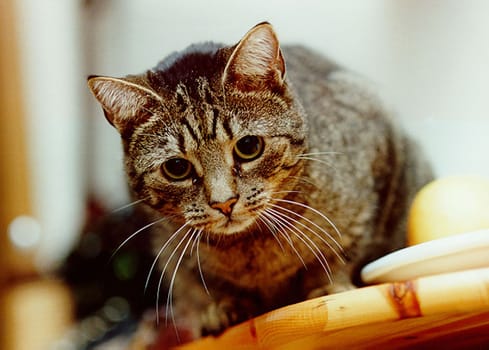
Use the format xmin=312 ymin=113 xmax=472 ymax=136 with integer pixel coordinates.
xmin=223 ymin=22 xmax=285 ymax=91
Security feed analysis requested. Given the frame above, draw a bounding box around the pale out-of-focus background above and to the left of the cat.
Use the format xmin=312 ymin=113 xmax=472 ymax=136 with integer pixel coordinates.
xmin=0 ymin=0 xmax=489 ymax=348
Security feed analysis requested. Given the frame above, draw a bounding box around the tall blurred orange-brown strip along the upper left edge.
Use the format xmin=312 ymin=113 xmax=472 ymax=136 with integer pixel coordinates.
xmin=0 ymin=0 xmax=33 ymax=282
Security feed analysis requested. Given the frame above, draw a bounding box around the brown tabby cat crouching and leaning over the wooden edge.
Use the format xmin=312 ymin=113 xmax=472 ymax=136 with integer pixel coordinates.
xmin=88 ymin=22 xmax=431 ymax=337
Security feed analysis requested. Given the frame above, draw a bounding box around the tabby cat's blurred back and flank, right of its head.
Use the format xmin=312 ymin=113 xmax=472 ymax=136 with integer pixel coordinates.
xmin=283 ymin=46 xmax=432 ymax=268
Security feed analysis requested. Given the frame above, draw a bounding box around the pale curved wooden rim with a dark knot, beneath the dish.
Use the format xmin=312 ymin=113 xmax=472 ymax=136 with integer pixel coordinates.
xmin=178 ymin=267 xmax=489 ymax=350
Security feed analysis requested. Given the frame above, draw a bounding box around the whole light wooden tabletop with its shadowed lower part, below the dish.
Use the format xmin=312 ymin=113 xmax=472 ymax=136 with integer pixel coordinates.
xmin=180 ymin=268 xmax=489 ymax=350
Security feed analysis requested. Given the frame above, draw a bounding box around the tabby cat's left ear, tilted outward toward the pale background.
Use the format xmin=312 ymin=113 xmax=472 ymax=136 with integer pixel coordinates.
xmin=88 ymin=76 xmax=161 ymax=132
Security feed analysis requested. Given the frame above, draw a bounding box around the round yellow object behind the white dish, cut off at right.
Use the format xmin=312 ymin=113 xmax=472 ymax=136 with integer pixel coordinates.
xmin=407 ymin=176 xmax=489 ymax=245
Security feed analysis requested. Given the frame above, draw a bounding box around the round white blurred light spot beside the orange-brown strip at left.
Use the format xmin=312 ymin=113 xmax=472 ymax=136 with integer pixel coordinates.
xmin=8 ymin=215 xmax=41 ymax=250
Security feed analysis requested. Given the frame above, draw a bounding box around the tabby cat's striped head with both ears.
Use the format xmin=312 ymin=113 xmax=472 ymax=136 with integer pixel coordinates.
xmin=88 ymin=23 xmax=306 ymax=235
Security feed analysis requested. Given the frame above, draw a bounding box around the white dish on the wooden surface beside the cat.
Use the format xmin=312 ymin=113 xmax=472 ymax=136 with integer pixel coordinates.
xmin=361 ymin=229 xmax=489 ymax=284
